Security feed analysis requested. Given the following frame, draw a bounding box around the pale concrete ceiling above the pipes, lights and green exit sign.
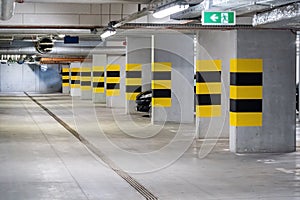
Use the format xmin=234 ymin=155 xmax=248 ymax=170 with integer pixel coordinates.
xmin=0 ymin=0 xmax=300 ymax=59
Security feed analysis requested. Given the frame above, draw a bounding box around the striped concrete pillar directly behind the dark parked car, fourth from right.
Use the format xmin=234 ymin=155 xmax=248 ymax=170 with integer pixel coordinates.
xmin=126 ymin=37 xmax=151 ymax=114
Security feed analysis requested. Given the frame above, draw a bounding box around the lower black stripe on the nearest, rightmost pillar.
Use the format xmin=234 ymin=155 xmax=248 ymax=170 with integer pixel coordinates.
xmin=230 ymin=99 xmax=262 ymax=112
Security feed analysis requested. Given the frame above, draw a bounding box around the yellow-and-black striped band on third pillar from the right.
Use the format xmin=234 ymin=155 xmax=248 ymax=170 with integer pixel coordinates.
xmin=151 ymin=62 xmax=172 ymax=107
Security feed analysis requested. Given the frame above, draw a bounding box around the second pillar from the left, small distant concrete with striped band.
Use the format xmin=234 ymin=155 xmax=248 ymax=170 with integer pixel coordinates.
xmin=70 ymin=62 xmax=81 ymax=97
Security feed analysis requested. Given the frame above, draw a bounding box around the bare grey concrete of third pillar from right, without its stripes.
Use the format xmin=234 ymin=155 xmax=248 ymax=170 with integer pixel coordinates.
xmin=152 ymin=32 xmax=194 ymax=123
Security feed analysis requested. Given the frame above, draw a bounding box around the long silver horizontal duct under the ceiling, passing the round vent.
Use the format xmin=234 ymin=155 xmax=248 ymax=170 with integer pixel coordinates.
xmin=0 ymin=47 xmax=126 ymax=56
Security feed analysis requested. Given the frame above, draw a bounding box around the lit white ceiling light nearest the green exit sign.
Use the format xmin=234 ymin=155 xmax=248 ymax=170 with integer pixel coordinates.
xmin=153 ymin=3 xmax=189 ymax=18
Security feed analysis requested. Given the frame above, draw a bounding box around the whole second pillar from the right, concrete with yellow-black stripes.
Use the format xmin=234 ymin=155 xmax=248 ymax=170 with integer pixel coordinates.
xmin=196 ymin=30 xmax=236 ymax=138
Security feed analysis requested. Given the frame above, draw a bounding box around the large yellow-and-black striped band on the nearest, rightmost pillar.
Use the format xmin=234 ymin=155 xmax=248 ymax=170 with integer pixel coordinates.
xmin=230 ymin=59 xmax=263 ymax=126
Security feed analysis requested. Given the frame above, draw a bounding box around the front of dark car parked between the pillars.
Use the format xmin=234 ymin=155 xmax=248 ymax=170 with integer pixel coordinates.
xmin=135 ymin=90 xmax=152 ymax=116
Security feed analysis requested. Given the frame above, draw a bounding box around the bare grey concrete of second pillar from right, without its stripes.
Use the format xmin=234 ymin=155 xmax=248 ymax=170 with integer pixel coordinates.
xmin=196 ymin=30 xmax=236 ymax=138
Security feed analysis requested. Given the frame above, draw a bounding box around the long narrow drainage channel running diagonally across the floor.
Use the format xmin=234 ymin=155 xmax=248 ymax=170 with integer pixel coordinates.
xmin=24 ymin=92 xmax=158 ymax=200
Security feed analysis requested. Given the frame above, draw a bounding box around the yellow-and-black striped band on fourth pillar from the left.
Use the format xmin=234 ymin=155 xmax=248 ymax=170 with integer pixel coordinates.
xmin=93 ymin=66 xmax=104 ymax=94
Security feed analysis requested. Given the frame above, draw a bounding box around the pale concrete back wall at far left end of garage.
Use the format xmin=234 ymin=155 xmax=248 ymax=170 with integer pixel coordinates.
xmin=0 ymin=64 xmax=62 ymax=93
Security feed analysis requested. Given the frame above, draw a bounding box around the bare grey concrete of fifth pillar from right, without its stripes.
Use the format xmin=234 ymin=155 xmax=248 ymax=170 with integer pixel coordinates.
xmin=106 ymin=56 xmax=126 ymax=108
